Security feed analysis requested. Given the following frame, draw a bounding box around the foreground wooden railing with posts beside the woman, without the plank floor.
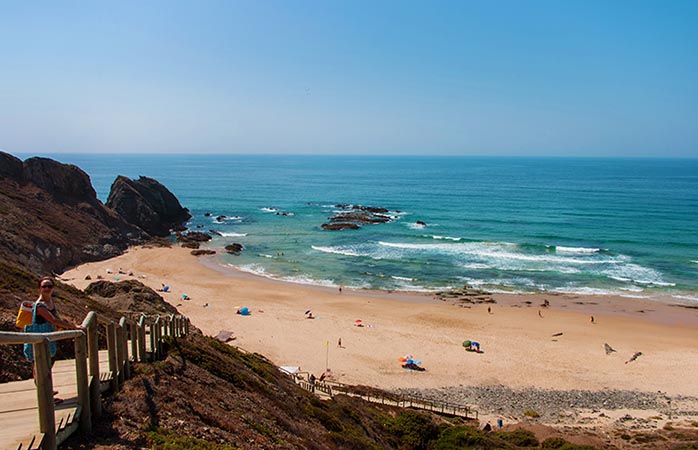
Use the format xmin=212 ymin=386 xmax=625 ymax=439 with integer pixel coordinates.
xmin=0 ymin=311 xmax=190 ymax=450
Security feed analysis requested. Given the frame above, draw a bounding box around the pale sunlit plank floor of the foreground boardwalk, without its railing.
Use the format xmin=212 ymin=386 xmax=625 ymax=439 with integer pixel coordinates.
xmin=0 ymin=350 xmax=111 ymax=450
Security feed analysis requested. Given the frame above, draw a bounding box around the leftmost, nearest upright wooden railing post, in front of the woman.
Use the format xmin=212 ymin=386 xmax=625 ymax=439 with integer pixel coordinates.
xmin=34 ymin=339 xmax=57 ymax=450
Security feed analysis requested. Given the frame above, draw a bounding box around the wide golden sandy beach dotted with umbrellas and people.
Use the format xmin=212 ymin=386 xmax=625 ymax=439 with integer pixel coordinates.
xmin=62 ymin=247 xmax=698 ymax=426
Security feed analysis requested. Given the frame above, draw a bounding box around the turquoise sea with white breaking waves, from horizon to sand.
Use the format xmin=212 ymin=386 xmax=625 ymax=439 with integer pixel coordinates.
xmin=39 ymin=154 xmax=698 ymax=301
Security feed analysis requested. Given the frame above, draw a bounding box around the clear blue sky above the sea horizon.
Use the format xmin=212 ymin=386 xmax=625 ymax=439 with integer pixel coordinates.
xmin=0 ymin=0 xmax=698 ymax=157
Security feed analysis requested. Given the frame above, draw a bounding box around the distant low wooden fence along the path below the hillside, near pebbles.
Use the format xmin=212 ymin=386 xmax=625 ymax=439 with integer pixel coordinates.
xmin=284 ymin=371 xmax=478 ymax=420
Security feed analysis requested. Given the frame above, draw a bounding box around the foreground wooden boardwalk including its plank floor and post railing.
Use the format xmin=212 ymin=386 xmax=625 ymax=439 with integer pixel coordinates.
xmin=0 ymin=311 xmax=189 ymax=450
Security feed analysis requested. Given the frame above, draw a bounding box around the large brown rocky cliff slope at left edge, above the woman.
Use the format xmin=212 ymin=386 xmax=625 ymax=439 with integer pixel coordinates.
xmin=0 ymin=152 xmax=150 ymax=274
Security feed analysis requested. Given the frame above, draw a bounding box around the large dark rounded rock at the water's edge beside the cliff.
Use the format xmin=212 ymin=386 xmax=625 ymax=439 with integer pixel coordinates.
xmin=107 ymin=176 xmax=191 ymax=236
